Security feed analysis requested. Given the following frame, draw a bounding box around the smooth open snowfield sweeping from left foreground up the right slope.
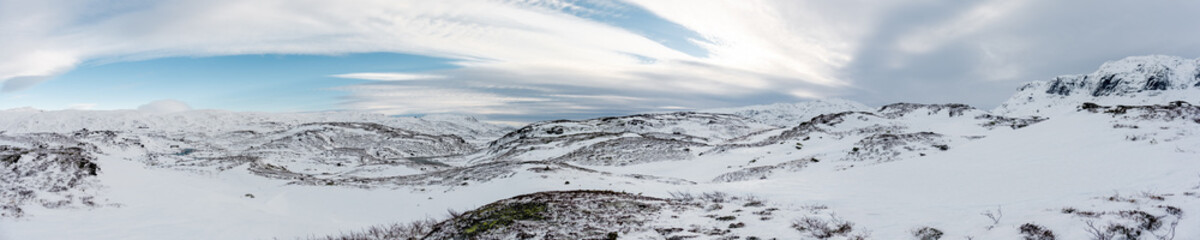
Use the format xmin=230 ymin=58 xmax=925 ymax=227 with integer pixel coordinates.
xmin=2 ymin=105 xmax=1200 ymax=239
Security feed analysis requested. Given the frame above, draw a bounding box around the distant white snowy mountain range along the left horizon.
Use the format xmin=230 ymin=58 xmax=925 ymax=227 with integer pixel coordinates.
xmin=0 ymin=108 xmax=511 ymax=143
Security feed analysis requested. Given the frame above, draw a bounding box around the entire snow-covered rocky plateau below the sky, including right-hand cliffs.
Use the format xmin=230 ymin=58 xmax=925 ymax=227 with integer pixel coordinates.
xmin=0 ymin=55 xmax=1200 ymax=240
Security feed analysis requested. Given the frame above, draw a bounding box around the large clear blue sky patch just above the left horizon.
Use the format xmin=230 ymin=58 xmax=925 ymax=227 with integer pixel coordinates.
xmin=0 ymin=53 xmax=456 ymax=112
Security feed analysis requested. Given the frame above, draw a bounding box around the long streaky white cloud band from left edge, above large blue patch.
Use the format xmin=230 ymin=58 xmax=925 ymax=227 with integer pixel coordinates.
xmin=0 ymin=0 xmax=868 ymax=116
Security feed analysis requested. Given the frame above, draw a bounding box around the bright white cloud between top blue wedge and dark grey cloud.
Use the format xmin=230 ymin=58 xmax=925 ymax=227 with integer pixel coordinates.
xmin=635 ymin=0 xmax=889 ymax=86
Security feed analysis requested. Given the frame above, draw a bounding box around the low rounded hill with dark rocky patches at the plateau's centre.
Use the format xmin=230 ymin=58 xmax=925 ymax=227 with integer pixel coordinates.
xmin=476 ymin=113 xmax=778 ymax=166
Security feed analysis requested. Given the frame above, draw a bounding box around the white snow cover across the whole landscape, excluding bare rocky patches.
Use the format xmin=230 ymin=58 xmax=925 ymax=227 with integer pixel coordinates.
xmin=0 ymin=56 xmax=1200 ymax=239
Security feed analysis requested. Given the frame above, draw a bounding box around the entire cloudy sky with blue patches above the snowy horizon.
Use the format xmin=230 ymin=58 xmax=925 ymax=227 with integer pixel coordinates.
xmin=0 ymin=0 xmax=1200 ymax=122
